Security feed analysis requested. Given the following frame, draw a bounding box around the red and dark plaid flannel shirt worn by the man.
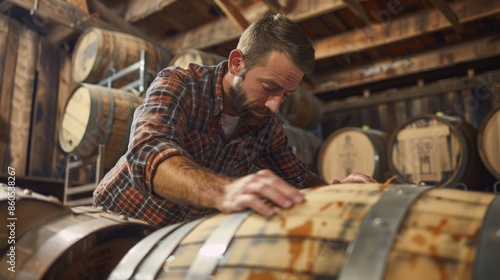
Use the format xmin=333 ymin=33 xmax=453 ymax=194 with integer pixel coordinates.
xmin=94 ymin=61 xmax=320 ymax=226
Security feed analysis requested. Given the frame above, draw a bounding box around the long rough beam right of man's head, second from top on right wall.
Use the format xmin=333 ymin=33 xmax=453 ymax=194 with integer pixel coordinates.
xmin=312 ymin=37 xmax=500 ymax=94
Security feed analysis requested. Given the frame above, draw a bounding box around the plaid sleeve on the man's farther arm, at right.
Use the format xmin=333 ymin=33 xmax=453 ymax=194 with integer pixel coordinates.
xmin=255 ymin=118 xmax=326 ymax=188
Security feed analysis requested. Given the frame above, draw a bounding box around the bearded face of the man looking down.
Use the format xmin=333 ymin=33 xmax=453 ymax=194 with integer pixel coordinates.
xmin=229 ymin=52 xmax=304 ymax=124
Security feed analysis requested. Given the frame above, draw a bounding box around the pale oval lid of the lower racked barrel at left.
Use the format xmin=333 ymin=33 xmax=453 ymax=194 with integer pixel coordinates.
xmin=59 ymin=86 xmax=91 ymax=153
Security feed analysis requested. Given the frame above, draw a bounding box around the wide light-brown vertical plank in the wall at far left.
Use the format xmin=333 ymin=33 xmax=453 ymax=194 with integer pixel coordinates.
xmin=9 ymin=25 xmax=38 ymax=176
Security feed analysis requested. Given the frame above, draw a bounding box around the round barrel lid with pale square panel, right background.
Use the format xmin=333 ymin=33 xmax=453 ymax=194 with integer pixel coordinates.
xmin=388 ymin=114 xmax=467 ymax=186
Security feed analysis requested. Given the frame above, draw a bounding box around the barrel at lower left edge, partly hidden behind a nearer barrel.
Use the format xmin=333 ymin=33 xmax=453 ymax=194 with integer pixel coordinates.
xmin=0 ymin=184 xmax=71 ymax=256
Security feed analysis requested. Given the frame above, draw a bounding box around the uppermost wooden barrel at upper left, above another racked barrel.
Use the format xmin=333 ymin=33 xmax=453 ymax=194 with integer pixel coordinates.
xmin=71 ymin=27 xmax=172 ymax=88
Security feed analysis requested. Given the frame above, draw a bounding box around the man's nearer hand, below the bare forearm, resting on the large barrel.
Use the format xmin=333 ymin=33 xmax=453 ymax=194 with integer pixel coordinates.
xmin=217 ymin=170 xmax=304 ymax=217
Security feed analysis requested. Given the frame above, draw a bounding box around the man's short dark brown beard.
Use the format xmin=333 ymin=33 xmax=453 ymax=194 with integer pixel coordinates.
xmin=229 ymin=74 xmax=273 ymax=125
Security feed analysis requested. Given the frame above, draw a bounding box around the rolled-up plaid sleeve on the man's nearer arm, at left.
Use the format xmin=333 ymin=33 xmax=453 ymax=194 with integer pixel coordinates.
xmin=127 ymin=68 xmax=193 ymax=193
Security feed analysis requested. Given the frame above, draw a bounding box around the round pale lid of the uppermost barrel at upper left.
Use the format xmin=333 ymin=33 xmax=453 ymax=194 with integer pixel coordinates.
xmin=71 ymin=28 xmax=101 ymax=83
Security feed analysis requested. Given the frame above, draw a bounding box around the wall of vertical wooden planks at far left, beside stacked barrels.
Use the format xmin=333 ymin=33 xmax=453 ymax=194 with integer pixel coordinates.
xmin=0 ymin=14 xmax=72 ymax=179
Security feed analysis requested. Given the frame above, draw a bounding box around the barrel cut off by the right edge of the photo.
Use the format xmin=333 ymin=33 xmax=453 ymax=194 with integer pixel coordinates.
xmin=478 ymin=107 xmax=500 ymax=180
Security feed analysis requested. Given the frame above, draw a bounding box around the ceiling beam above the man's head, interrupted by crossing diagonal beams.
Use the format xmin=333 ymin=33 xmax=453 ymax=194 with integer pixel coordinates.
xmin=162 ymin=0 xmax=346 ymax=50
